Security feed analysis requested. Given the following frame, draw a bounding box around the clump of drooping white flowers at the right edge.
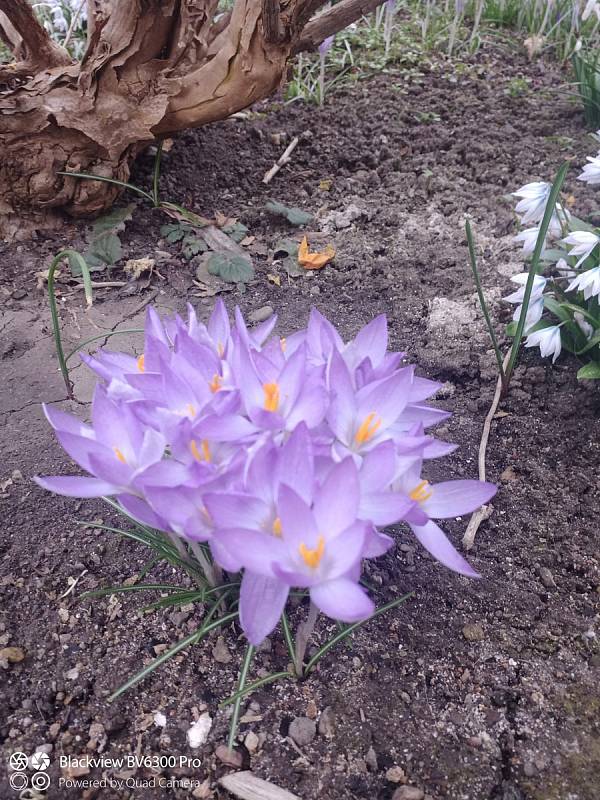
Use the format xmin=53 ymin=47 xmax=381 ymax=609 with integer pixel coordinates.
xmin=504 ymin=140 xmax=600 ymax=377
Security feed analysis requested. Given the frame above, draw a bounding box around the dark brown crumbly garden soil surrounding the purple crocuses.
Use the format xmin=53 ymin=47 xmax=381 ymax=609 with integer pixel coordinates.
xmin=0 ymin=40 xmax=600 ymax=800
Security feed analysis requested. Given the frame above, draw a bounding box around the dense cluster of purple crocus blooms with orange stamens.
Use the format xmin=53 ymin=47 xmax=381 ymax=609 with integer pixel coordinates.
xmin=37 ymin=302 xmax=495 ymax=644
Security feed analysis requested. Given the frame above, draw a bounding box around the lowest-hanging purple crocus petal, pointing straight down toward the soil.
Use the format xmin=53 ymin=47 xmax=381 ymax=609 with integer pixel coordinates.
xmin=240 ymin=571 xmax=290 ymax=645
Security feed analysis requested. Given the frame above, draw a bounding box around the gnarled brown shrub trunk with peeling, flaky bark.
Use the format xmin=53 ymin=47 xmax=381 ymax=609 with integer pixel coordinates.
xmin=0 ymin=0 xmax=381 ymax=235
